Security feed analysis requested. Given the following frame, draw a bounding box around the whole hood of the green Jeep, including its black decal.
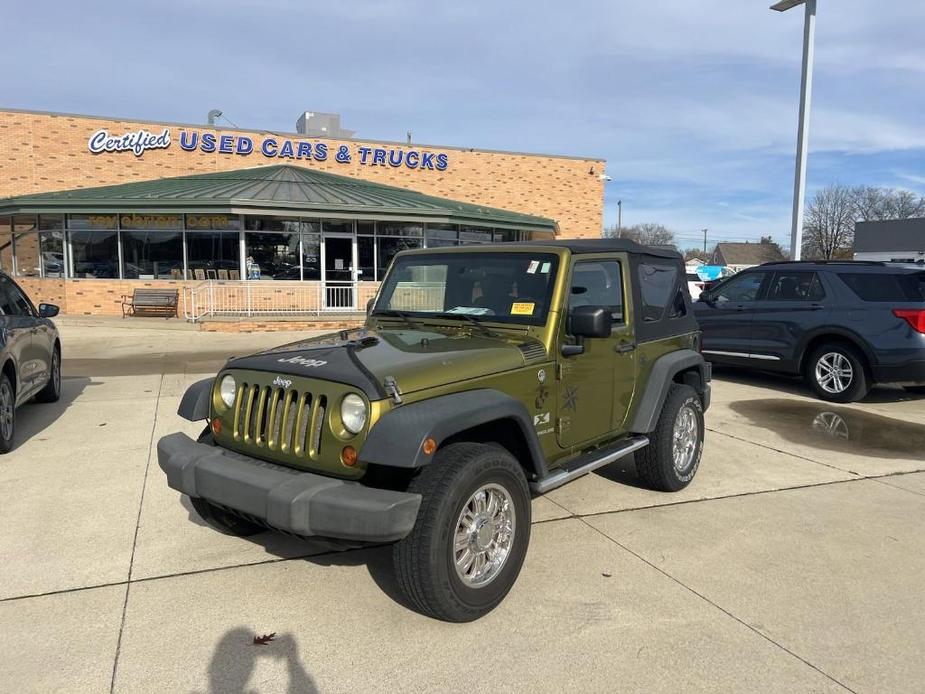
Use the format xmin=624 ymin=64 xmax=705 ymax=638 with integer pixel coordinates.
xmin=226 ymin=326 xmax=542 ymax=400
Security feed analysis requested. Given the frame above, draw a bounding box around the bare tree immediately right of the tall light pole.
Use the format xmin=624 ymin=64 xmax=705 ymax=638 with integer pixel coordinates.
xmin=803 ymin=185 xmax=857 ymax=260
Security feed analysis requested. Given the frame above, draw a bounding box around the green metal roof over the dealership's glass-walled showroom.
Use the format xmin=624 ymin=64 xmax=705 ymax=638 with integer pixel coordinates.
xmin=0 ymin=165 xmax=557 ymax=233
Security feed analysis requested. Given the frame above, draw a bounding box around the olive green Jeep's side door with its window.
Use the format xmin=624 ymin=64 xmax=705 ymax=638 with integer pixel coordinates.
xmin=556 ymin=254 xmax=635 ymax=448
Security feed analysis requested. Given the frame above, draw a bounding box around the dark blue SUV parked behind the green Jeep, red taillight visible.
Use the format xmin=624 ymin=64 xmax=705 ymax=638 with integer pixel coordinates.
xmin=694 ymin=261 xmax=925 ymax=402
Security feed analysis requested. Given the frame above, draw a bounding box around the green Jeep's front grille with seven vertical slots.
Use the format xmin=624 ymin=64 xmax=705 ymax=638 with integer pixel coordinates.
xmin=232 ymin=383 xmax=328 ymax=458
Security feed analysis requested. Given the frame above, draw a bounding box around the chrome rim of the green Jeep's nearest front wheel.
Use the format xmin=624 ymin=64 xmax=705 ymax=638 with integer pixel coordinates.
xmin=453 ymin=484 xmax=517 ymax=588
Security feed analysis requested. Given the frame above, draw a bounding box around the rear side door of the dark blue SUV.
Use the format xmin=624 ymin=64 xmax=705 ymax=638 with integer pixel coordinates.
xmin=750 ymin=270 xmax=831 ymax=371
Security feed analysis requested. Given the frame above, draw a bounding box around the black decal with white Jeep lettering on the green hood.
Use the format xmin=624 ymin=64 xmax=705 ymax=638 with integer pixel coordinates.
xmin=225 ymin=338 xmax=387 ymax=400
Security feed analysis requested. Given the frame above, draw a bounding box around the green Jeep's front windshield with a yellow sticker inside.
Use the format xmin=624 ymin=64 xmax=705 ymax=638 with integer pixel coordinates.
xmin=372 ymin=252 xmax=559 ymax=325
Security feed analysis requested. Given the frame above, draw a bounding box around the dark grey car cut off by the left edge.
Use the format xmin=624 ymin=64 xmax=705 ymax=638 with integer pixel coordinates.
xmin=0 ymin=272 xmax=61 ymax=453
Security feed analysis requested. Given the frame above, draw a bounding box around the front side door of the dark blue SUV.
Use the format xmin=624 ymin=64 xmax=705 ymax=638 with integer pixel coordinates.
xmin=694 ymin=270 xmax=771 ymax=363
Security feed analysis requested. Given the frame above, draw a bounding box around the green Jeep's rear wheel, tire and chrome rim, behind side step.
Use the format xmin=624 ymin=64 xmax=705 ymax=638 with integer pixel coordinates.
xmin=635 ymin=383 xmax=703 ymax=492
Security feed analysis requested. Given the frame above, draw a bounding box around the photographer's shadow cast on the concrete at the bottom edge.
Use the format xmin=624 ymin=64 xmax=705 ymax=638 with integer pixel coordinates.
xmin=202 ymin=627 xmax=319 ymax=694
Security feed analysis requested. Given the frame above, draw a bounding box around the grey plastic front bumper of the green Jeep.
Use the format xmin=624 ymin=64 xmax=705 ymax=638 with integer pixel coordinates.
xmin=157 ymin=434 xmax=421 ymax=542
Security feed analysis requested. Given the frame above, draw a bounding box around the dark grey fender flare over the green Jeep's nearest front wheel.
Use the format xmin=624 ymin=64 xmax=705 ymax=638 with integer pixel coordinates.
xmin=359 ymin=388 xmax=546 ymax=477
